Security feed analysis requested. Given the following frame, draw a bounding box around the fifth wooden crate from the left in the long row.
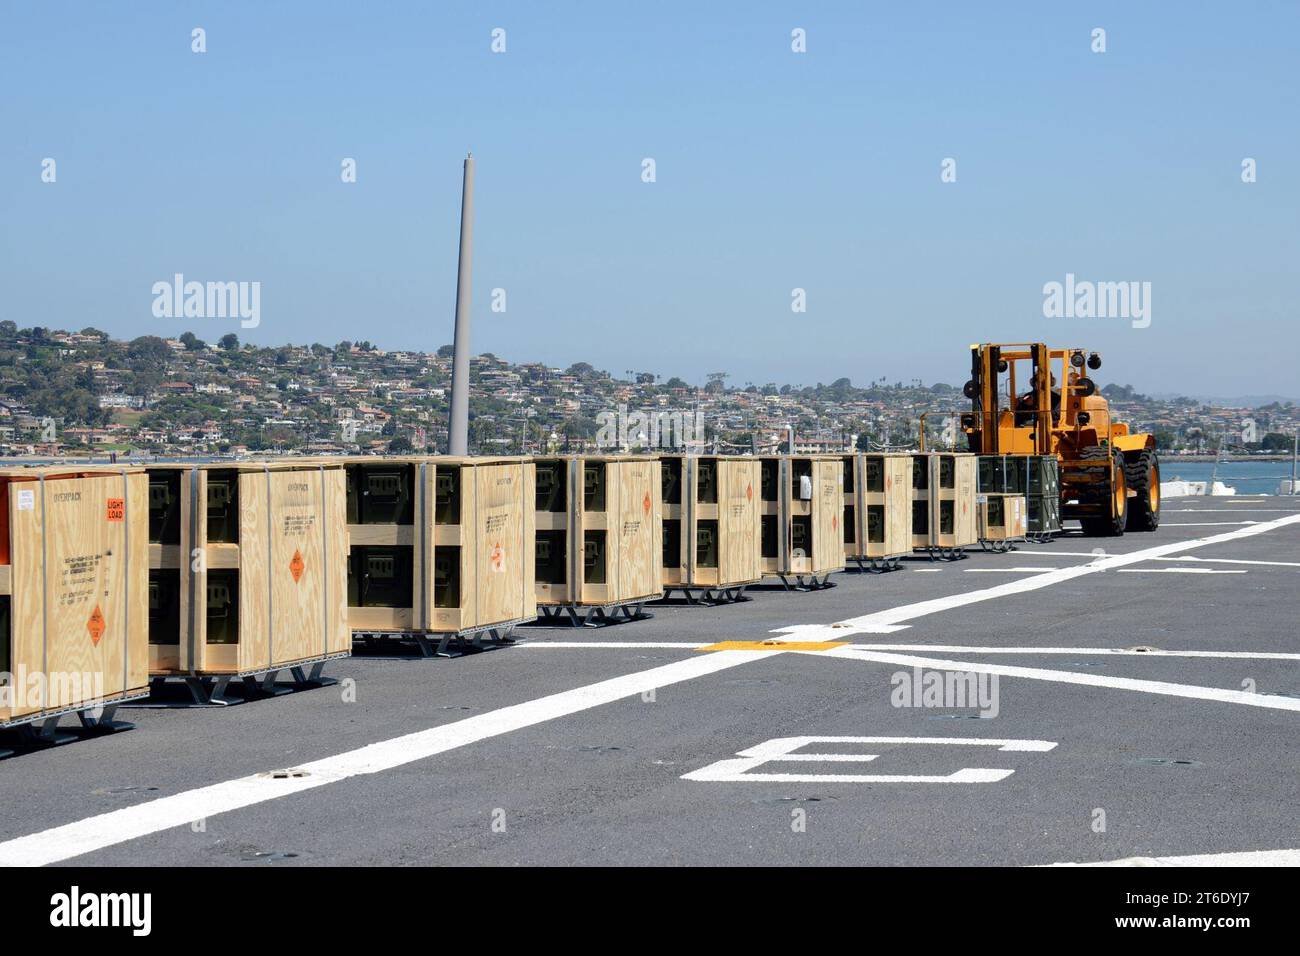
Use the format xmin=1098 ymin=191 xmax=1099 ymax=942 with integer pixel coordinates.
xmin=659 ymin=455 xmax=763 ymax=592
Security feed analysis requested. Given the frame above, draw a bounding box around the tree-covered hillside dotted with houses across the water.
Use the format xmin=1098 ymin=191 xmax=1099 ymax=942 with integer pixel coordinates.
xmin=0 ymin=321 xmax=1300 ymax=457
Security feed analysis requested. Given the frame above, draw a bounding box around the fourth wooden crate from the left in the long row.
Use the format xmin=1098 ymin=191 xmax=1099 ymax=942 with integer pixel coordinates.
xmin=536 ymin=455 xmax=663 ymax=607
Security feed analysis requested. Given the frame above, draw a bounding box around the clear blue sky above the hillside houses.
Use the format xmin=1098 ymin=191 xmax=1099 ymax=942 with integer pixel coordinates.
xmin=0 ymin=0 xmax=1300 ymax=398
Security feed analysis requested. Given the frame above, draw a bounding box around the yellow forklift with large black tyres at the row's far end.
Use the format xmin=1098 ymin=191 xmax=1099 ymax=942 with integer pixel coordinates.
xmin=962 ymin=342 xmax=1160 ymax=536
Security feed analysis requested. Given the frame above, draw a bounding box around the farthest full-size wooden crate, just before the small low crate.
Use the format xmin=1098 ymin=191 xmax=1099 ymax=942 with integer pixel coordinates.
xmin=911 ymin=451 xmax=979 ymax=557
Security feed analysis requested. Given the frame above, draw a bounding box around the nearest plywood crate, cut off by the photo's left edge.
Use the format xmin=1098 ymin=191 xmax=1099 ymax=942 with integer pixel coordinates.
xmin=0 ymin=467 xmax=148 ymax=726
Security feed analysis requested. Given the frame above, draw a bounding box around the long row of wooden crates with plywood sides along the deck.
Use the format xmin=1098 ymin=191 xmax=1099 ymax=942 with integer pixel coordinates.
xmin=0 ymin=454 xmax=1055 ymax=724
